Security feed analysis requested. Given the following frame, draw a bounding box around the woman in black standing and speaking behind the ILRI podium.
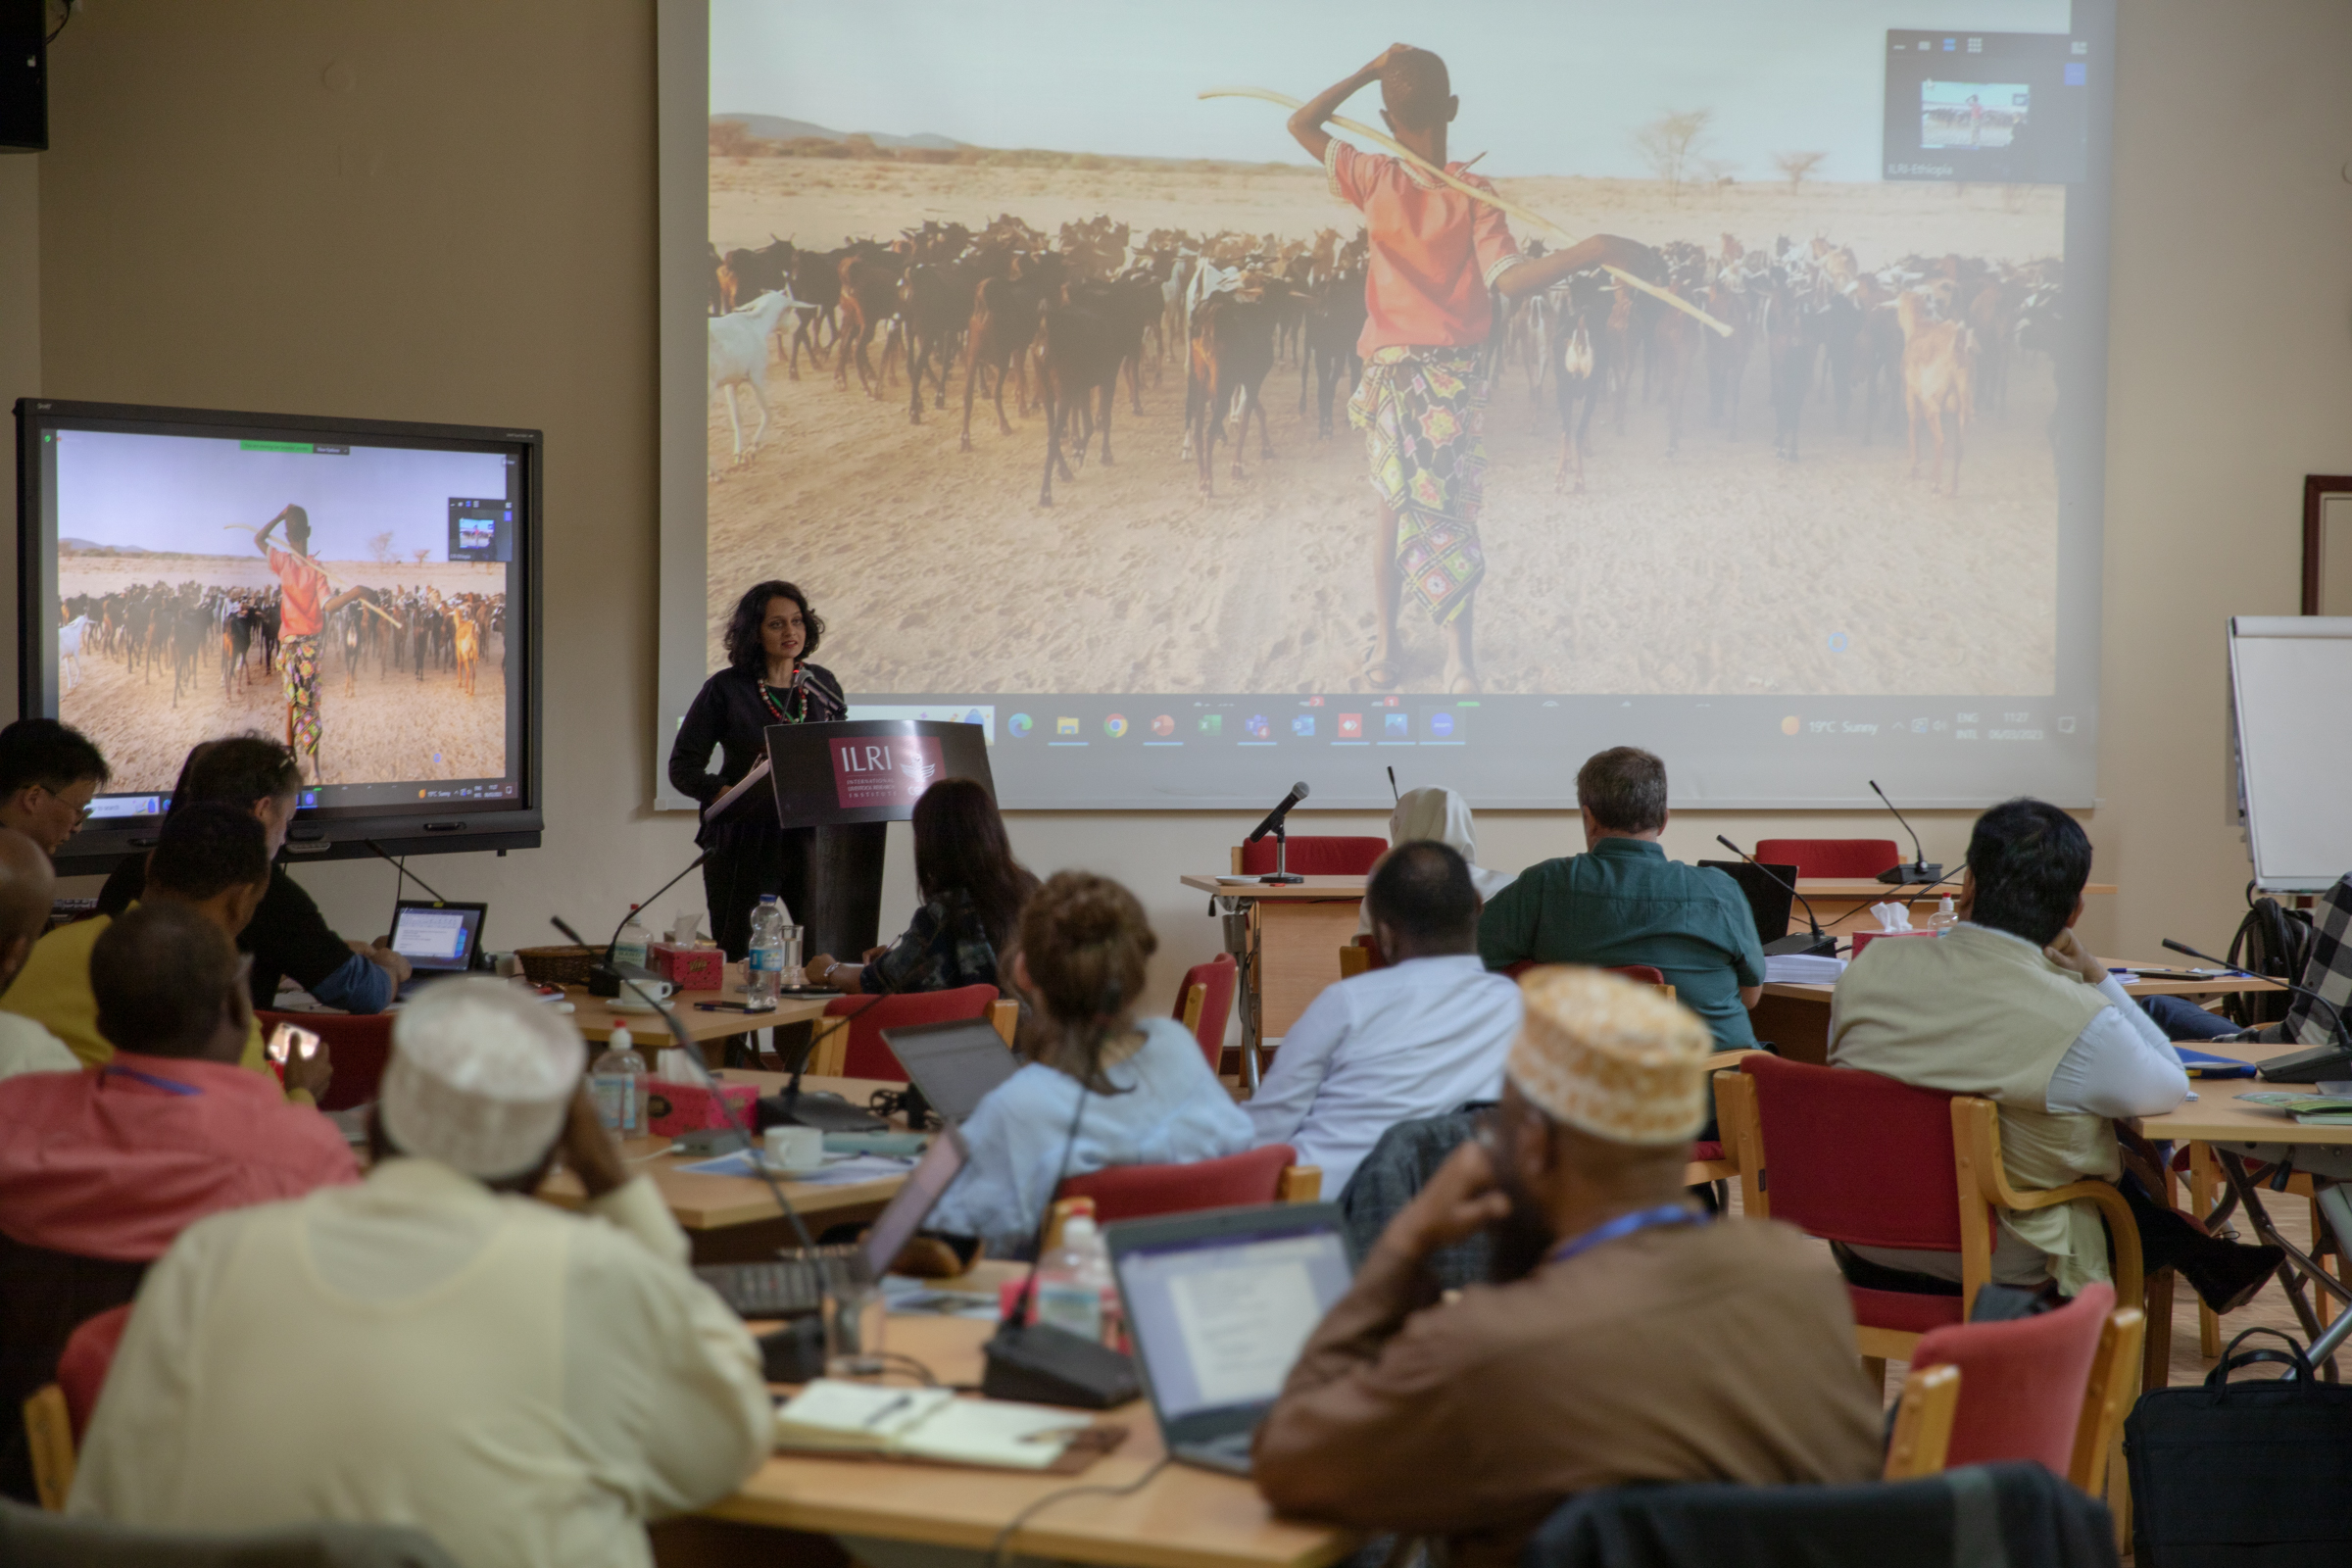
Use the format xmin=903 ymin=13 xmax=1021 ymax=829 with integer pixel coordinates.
xmin=670 ymin=581 xmax=849 ymax=959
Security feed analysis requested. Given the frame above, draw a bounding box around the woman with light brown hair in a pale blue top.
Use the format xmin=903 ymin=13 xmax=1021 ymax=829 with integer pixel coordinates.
xmin=929 ymin=872 xmax=1251 ymax=1255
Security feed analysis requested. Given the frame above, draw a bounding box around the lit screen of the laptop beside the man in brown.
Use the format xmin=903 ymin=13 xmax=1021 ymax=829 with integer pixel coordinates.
xmin=1117 ymin=1230 xmax=1352 ymax=1422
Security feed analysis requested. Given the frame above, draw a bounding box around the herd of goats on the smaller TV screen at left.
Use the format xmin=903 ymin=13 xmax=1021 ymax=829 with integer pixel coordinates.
xmin=57 ymin=581 xmax=506 ymax=708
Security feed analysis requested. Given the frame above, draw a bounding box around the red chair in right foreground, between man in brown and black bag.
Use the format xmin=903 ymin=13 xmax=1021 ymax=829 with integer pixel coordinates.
xmin=1912 ymin=1284 xmax=2145 ymax=1495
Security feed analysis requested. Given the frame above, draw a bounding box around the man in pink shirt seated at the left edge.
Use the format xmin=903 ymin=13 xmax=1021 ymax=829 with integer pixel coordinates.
xmin=0 ymin=901 xmax=360 ymax=1497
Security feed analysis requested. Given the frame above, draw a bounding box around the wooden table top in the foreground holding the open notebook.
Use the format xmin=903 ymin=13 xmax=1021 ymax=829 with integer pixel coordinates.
xmin=708 ymin=1316 xmax=1359 ymax=1568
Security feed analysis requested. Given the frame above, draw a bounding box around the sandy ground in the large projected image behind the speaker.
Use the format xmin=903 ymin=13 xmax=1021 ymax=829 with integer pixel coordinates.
xmin=708 ymin=160 xmax=2063 ymax=696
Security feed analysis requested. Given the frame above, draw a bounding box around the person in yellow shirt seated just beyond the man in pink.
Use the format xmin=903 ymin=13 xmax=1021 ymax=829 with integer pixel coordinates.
xmin=0 ymin=802 xmax=327 ymax=1098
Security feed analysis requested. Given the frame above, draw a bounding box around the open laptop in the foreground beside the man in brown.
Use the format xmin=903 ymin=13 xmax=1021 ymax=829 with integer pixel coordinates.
xmin=1103 ymin=1203 xmax=1354 ymax=1476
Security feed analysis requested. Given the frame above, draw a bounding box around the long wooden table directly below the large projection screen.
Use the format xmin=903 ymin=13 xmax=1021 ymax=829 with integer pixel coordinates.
xmin=1183 ymin=872 xmax=2115 ymax=1053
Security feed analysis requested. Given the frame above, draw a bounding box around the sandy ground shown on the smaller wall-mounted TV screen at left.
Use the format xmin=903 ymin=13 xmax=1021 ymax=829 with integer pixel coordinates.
xmin=59 ymin=555 xmax=506 ymax=792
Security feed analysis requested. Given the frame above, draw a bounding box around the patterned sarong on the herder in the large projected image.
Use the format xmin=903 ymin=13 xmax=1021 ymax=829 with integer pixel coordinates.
xmin=1348 ymin=348 xmax=1487 ymax=625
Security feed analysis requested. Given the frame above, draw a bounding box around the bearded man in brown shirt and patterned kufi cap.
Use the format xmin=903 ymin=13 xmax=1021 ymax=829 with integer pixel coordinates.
xmin=1256 ymin=966 xmax=1880 ymax=1568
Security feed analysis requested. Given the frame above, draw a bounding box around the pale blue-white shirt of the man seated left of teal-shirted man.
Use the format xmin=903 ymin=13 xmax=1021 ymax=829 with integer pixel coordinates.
xmin=1242 ymin=953 xmax=1519 ymax=1199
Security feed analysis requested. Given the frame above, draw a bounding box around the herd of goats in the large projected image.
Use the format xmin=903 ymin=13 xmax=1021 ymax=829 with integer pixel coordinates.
xmin=708 ymin=214 xmax=2063 ymax=506
